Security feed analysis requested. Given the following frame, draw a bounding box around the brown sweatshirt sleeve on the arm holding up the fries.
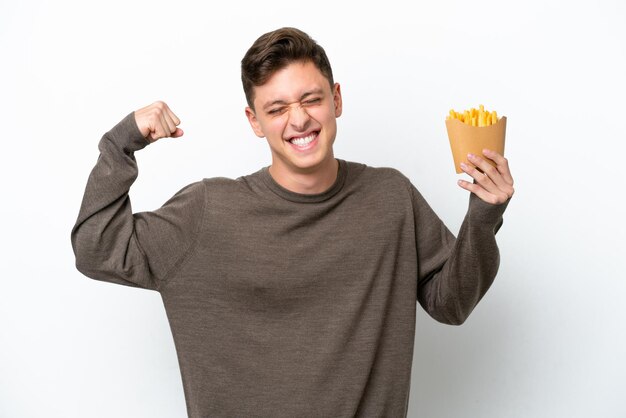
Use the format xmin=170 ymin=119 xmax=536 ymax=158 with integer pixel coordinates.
xmin=412 ymin=187 xmax=508 ymax=325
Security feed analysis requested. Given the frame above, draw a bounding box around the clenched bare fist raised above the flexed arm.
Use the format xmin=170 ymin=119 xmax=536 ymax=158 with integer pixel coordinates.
xmin=135 ymin=101 xmax=183 ymax=142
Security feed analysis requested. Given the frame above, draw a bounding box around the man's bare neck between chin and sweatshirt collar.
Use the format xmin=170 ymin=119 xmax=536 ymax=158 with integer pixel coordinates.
xmin=269 ymin=158 xmax=339 ymax=194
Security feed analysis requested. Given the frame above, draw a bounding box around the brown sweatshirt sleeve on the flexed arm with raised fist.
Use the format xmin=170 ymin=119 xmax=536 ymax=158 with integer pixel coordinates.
xmin=71 ymin=113 xmax=205 ymax=290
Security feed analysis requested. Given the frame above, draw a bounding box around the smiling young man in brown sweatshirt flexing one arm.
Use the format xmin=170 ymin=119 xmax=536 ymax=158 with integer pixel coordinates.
xmin=72 ymin=28 xmax=513 ymax=417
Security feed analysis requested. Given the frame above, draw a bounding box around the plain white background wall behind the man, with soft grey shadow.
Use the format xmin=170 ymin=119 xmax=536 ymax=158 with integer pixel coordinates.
xmin=0 ymin=0 xmax=626 ymax=418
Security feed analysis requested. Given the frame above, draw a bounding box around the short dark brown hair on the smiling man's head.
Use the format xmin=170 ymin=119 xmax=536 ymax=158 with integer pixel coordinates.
xmin=241 ymin=28 xmax=335 ymax=109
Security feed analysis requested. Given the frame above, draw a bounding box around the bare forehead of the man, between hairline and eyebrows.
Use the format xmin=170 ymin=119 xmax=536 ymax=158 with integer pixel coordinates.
xmin=254 ymin=62 xmax=331 ymax=107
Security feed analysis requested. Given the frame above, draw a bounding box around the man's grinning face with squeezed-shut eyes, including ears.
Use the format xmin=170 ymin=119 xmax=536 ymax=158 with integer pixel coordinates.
xmin=246 ymin=62 xmax=341 ymax=176
